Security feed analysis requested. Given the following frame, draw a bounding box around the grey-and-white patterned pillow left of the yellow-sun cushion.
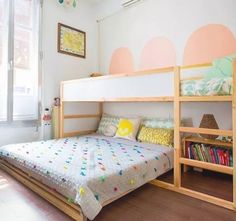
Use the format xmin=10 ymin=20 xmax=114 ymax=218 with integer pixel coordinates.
xmin=97 ymin=114 xmax=120 ymax=137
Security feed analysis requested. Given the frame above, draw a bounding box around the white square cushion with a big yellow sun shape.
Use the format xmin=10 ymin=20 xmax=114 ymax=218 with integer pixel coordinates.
xmin=115 ymin=118 xmax=141 ymax=140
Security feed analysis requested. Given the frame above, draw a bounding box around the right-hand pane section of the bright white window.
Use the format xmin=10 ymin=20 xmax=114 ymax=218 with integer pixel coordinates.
xmin=13 ymin=0 xmax=38 ymax=120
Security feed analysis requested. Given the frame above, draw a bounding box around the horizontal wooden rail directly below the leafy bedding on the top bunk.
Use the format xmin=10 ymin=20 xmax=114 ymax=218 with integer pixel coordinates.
xmin=179 ymin=96 xmax=233 ymax=102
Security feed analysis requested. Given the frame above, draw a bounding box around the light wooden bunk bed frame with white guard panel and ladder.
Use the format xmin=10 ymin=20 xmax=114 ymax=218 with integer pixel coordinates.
xmin=0 ymin=61 xmax=236 ymax=221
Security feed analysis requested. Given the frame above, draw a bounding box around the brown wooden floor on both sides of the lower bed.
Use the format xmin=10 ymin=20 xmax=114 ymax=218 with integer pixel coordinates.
xmin=0 ymin=168 xmax=236 ymax=221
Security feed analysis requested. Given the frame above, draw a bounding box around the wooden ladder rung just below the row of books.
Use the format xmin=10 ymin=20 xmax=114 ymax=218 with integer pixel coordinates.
xmin=180 ymin=157 xmax=233 ymax=175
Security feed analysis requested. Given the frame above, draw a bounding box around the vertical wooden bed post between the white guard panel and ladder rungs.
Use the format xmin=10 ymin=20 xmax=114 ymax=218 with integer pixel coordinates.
xmin=174 ymin=66 xmax=181 ymax=188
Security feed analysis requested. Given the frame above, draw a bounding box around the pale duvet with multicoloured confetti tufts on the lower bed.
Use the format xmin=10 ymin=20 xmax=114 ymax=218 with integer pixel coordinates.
xmin=0 ymin=135 xmax=174 ymax=220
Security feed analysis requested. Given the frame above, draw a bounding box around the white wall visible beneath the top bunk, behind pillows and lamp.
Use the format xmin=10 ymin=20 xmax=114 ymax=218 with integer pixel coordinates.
xmin=104 ymin=102 xmax=232 ymax=129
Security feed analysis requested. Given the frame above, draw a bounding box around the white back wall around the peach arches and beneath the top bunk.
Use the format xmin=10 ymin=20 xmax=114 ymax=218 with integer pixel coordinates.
xmin=97 ymin=0 xmax=236 ymax=129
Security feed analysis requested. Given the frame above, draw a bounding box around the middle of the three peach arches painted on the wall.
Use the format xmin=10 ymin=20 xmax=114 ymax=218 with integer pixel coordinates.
xmin=140 ymin=37 xmax=176 ymax=70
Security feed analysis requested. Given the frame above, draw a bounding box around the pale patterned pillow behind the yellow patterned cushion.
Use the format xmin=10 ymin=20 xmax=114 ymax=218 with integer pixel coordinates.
xmin=142 ymin=118 xmax=174 ymax=128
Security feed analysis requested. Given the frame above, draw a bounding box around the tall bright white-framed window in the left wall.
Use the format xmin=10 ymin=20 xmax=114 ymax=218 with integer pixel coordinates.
xmin=0 ymin=0 xmax=40 ymax=123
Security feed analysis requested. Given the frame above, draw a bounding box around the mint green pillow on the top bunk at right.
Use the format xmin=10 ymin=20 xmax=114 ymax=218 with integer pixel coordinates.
xmin=205 ymin=54 xmax=236 ymax=79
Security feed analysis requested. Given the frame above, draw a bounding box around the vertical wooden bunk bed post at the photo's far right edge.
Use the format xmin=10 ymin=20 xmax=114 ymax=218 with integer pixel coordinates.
xmin=232 ymin=59 xmax=236 ymax=210
